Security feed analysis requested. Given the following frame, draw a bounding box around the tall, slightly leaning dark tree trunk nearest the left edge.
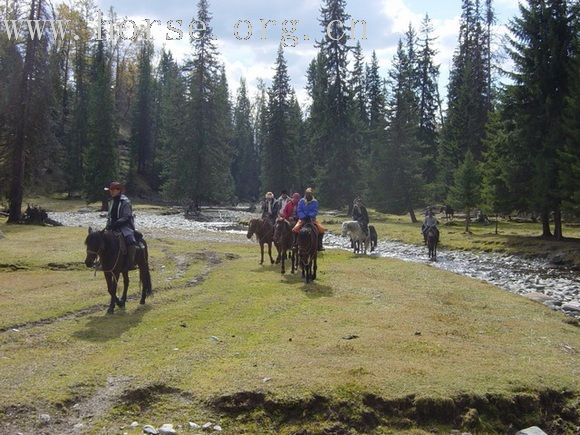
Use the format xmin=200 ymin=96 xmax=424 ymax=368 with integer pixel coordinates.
xmin=8 ymin=0 xmax=42 ymax=223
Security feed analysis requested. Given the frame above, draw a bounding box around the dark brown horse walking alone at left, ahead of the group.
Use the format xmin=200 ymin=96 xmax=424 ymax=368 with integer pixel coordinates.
xmin=85 ymin=228 xmax=153 ymax=314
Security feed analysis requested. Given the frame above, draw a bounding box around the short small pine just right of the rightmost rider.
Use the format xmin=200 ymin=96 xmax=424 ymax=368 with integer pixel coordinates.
xmin=448 ymin=151 xmax=481 ymax=233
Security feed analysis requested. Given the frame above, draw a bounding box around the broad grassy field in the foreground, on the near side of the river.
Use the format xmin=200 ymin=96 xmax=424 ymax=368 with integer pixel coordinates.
xmin=0 ymin=221 xmax=580 ymax=434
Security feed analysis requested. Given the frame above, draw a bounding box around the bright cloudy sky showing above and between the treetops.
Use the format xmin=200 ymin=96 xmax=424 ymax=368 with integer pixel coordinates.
xmin=75 ymin=0 xmax=519 ymax=105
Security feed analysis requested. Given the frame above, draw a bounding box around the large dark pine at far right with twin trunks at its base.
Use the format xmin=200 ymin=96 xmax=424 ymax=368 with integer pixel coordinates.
xmin=509 ymin=0 xmax=573 ymax=239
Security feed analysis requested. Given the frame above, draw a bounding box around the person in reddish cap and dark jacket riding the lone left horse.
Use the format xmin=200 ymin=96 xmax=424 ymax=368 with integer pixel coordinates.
xmin=105 ymin=181 xmax=137 ymax=270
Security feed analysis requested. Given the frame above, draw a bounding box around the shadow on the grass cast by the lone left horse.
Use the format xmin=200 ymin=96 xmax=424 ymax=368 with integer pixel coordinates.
xmin=73 ymin=305 xmax=151 ymax=343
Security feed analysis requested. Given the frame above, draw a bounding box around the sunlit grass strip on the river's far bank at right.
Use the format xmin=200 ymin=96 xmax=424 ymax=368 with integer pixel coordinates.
xmin=321 ymin=210 xmax=580 ymax=267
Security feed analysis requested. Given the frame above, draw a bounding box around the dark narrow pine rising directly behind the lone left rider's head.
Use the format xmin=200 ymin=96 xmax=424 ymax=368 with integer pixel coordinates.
xmin=85 ymin=41 xmax=118 ymax=202
